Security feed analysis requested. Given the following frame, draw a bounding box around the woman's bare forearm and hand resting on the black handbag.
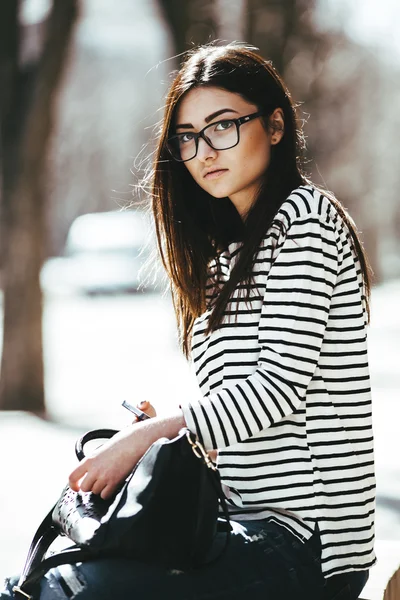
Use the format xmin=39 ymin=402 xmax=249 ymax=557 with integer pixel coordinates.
xmin=69 ymin=409 xmax=186 ymax=499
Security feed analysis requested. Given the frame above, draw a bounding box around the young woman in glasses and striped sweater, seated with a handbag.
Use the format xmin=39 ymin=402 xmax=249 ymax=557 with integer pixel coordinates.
xmin=2 ymin=43 xmax=375 ymax=600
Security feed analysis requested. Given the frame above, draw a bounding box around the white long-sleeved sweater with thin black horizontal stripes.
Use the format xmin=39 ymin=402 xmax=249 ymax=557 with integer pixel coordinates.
xmin=182 ymin=185 xmax=375 ymax=577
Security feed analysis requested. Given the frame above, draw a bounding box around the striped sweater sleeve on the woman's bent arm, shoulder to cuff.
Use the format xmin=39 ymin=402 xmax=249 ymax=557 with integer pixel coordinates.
xmin=181 ymin=214 xmax=338 ymax=450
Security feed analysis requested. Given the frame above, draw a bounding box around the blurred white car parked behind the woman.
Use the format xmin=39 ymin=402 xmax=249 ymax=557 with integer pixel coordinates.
xmin=40 ymin=210 xmax=159 ymax=295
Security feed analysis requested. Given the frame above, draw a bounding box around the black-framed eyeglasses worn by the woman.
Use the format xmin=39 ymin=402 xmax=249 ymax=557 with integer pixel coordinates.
xmin=166 ymin=112 xmax=263 ymax=162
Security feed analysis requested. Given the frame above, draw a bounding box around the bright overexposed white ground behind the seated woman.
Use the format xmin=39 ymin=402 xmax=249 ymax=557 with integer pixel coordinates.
xmin=0 ymin=282 xmax=400 ymax=597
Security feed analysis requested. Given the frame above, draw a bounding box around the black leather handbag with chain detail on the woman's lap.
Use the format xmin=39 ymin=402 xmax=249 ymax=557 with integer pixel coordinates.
xmin=13 ymin=428 xmax=230 ymax=600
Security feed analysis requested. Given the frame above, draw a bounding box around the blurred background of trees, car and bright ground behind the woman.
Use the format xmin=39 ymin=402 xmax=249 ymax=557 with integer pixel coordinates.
xmin=0 ymin=0 xmax=400 ymax=592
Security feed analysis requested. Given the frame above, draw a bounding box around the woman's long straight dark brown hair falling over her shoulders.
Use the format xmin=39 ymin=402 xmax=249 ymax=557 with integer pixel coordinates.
xmin=149 ymin=42 xmax=370 ymax=356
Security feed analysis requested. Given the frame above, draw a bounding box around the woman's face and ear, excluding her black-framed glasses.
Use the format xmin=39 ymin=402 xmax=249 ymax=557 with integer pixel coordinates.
xmin=175 ymin=87 xmax=283 ymax=217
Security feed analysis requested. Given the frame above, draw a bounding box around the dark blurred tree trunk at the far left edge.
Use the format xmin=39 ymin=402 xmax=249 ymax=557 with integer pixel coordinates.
xmin=0 ymin=0 xmax=78 ymax=413
